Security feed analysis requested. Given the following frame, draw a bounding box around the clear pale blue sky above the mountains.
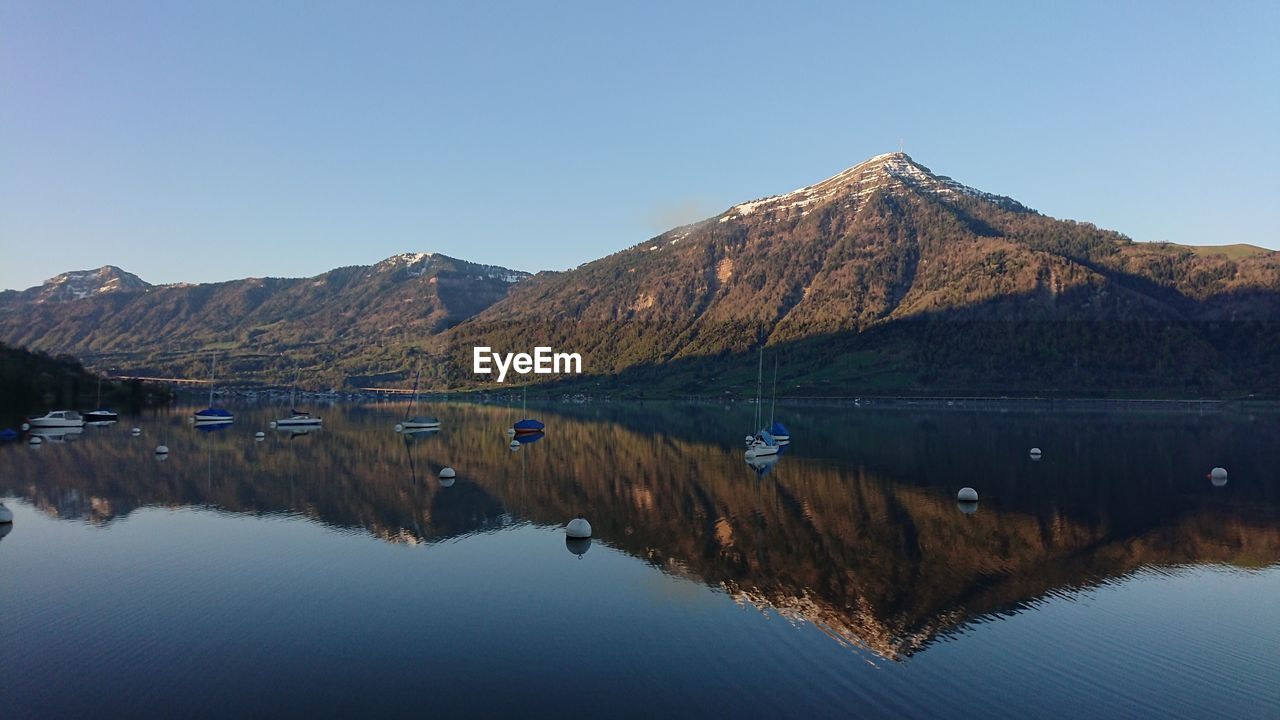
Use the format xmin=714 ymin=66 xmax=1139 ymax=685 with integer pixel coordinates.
xmin=0 ymin=0 xmax=1280 ymax=288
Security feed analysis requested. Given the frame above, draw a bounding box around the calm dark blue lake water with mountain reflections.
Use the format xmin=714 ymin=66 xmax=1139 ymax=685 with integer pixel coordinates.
xmin=0 ymin=404 xmax=1280 ymax=719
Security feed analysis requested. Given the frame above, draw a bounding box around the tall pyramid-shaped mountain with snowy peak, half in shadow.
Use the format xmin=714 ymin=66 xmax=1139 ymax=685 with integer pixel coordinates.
xmin=448 ymin=152 xmax=1280 ymax=392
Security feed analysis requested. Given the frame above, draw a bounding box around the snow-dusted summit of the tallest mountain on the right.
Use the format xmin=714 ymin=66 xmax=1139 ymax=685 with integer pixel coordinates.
xmin=719 ymin=151 xmax=1029 ymax=223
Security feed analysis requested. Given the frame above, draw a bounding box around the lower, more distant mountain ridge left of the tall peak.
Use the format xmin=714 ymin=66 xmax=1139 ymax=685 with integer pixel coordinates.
xmin=0 ymin=254 xmax=527 ymax=384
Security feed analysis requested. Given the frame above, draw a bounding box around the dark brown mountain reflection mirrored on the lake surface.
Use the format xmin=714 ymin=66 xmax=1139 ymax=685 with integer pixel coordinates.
xmin=0 ymin=404 xmax=1280 ymax=660
